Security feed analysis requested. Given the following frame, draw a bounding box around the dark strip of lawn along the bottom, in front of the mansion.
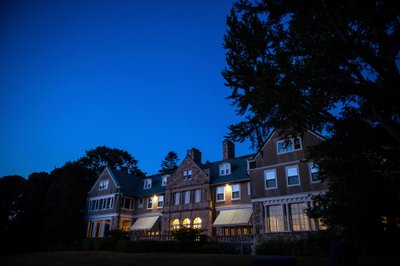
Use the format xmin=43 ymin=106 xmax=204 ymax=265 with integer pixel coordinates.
xmin=0 ymin=251 xmax=329 ymax=266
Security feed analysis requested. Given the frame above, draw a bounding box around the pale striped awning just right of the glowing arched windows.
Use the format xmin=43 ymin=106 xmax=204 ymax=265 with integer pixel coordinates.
xmin=213 ymin=208 xmax=253 ymax=227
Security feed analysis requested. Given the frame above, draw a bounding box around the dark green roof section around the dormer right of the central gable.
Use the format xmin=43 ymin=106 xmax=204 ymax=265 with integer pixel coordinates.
xmin=205 ymin=154 xmax=254 ymax=185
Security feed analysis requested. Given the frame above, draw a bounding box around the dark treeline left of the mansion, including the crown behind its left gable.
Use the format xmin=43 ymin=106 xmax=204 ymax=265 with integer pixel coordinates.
xmin=0 ymin=146 xmax=144 ymax=253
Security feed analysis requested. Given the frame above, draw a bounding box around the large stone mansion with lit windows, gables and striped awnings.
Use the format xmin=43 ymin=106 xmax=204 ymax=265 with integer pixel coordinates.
xmin=85 ymin=131 xmax=326 ymax=242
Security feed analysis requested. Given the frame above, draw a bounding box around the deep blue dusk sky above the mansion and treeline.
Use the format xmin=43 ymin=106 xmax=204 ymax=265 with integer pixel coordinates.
xmin=0 ymin=0 xmax=252 ymax=177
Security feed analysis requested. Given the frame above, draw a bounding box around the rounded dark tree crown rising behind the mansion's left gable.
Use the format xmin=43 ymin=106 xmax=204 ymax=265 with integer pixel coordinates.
xmin=77 ymin=146 xmax=144 ymax=177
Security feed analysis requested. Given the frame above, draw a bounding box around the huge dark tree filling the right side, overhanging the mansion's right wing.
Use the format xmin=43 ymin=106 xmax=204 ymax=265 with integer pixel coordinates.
xmin=222 ymin=0 xmax=400 ymax=254
